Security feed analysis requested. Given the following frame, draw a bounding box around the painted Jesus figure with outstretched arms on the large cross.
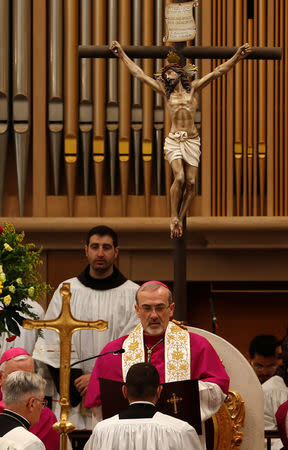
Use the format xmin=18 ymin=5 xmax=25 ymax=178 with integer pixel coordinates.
xmin=110 ymin=41 xmax=251 ymax=238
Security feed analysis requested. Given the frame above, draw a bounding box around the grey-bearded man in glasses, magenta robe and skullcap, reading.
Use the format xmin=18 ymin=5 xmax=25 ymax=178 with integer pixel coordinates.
xmin=85 ymin=281 xmax=229 ymax=448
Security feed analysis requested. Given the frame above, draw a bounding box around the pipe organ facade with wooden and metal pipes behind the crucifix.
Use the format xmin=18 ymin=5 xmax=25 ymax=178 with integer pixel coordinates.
xmin=0 ymin=0 xmax=288 ymax=218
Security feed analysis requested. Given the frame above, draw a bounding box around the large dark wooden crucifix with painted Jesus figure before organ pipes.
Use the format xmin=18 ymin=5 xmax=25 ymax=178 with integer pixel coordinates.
xmin=79 ymin=0 xmax=281 ymax=320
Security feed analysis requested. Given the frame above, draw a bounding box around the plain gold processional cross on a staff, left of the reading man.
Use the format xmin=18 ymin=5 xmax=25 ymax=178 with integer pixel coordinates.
xmin=23 ymin=283 xmax=108 ymax=450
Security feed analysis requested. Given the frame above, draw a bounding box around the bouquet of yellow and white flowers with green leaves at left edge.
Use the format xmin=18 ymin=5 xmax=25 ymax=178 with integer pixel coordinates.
xmin=0 ymin=223 xmax=51 ymax=341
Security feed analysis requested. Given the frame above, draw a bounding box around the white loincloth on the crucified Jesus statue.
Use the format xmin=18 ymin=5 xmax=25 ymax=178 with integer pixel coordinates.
xmin=164 ymin=131 xmax=201 ymax=167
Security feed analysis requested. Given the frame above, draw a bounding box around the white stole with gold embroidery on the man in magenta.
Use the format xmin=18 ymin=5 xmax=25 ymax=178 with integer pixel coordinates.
xmin=122 ymin=322 xmax=191 ymax=383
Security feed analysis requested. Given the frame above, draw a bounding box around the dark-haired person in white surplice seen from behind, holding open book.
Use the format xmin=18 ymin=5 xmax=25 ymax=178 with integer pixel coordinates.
xmin=84 ymin=363 xmax=202 ymax=450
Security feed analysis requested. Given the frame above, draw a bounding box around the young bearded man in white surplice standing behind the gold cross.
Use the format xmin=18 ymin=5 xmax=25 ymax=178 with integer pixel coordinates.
xmin=33 ymin=226 xmax=139 ymax=429
